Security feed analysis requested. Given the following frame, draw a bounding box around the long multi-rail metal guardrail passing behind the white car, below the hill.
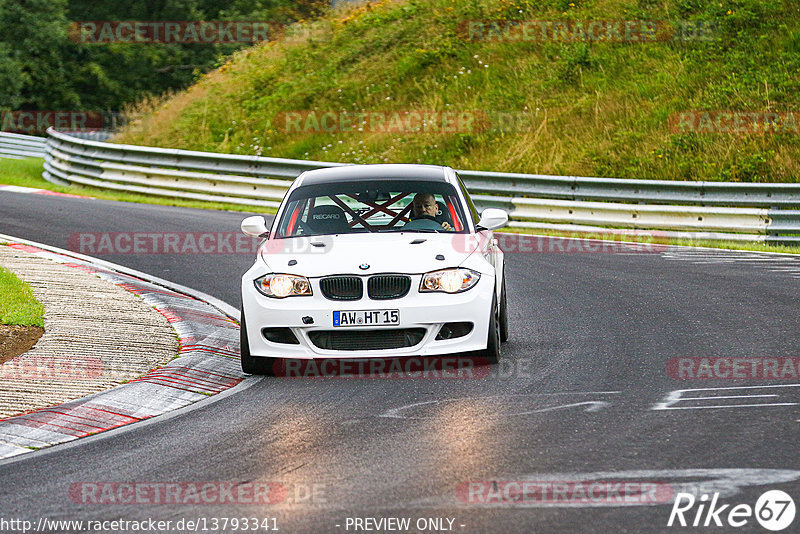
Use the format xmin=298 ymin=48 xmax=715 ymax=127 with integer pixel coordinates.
xmin=43 ymin=129 xmax=800 ymax=243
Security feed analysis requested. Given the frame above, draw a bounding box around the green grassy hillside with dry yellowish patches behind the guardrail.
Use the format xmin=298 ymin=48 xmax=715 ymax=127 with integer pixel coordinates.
xmin=117 ymin=0 xmax=800 ymax=182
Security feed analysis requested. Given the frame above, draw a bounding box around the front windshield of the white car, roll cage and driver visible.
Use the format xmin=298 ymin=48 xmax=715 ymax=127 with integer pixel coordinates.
xmin=275 ymin=179 xmax=467 ymax=238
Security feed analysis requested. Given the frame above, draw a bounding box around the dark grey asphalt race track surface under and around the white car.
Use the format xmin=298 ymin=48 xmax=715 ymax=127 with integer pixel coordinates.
xmin=0 ymin=192 xmax=800 ymax=533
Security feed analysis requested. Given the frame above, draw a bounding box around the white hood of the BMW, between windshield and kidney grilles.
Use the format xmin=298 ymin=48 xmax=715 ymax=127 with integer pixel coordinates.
xmin=259 ymin=232 xmax=478 ymax=277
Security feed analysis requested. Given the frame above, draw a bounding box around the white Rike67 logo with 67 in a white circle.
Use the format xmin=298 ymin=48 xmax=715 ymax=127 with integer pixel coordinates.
xmin=667 ymin=490 xmax=795 ymax=532
